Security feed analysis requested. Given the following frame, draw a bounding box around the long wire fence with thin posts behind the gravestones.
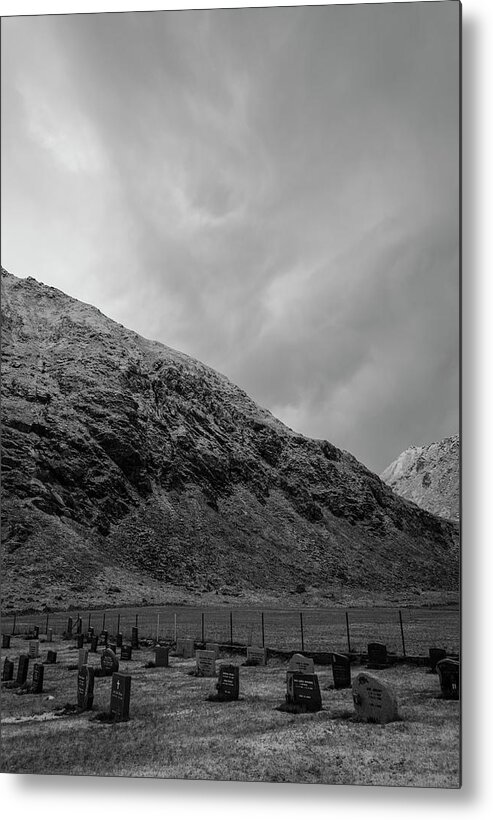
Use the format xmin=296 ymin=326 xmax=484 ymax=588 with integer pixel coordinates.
xmin=2 ymin=606 xmax=460 ymax=655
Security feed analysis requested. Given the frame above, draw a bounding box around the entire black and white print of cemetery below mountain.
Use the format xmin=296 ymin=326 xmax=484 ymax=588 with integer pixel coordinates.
xmin=1 ymin=0 xmax=463 ymax=790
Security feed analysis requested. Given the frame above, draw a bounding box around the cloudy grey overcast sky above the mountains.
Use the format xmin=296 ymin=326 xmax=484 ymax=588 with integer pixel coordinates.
xmin=1 ymin=1 xmax=459 ymax=472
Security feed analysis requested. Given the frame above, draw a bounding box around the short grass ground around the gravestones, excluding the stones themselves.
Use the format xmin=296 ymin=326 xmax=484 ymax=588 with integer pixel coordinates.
xmin=1 ymin=637 xmax=460 ymax=788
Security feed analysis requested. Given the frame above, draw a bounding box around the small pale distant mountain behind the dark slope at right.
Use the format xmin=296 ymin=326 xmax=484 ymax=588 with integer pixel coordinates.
xmin=380 ymin=436 xmax=460 ymax=521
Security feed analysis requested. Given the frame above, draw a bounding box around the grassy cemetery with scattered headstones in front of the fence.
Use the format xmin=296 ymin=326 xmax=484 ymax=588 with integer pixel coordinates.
xmin=2 ymin=620 xmax=460 ymax=787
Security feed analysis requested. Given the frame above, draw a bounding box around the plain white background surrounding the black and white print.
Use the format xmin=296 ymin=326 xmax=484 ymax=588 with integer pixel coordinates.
xmin=0 ymin=0 xmax=493 ymax=820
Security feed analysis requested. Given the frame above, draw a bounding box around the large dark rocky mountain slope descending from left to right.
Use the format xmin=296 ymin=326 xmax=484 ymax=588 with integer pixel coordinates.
xmin=2 ymin=271 xmax=459 ymax=611
